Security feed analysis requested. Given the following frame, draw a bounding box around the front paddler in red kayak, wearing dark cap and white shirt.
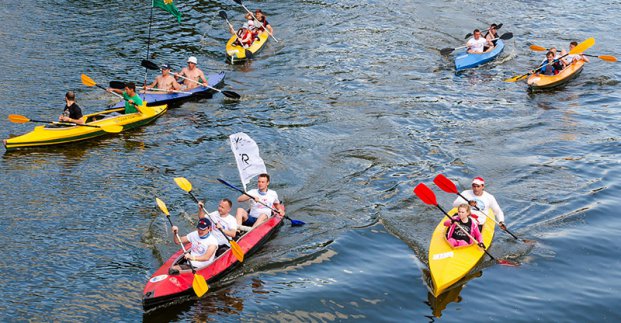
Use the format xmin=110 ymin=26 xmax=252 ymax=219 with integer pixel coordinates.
xmin=169 ymin=218 xmax=218 ymax=274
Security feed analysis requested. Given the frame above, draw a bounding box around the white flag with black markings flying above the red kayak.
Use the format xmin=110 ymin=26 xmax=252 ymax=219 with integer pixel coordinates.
xmin=229 ymin=132 xmax=267 ymax=191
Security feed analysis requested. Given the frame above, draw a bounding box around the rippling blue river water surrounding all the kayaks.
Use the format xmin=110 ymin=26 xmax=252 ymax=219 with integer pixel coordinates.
xmin=0 ymin=0 xmax=621 ymax=322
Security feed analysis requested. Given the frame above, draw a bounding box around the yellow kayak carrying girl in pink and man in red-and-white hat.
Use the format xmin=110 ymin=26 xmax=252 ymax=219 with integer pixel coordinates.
xmin=429 ymin=208 xmax=496 ymax=297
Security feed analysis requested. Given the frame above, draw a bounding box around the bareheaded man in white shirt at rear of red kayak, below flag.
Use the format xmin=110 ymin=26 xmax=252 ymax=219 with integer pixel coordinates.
xmin=235 ymin=174 xmax=285 ymax=228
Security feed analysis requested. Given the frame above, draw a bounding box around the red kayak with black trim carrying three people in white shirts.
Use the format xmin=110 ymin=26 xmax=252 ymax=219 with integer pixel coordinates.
xmin=142 ymin=216 xmax=283 ymax=310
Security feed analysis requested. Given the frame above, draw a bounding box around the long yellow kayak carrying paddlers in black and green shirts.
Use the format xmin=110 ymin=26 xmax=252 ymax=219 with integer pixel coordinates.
xmin=4 ymin=105 xmax=168 ymax=150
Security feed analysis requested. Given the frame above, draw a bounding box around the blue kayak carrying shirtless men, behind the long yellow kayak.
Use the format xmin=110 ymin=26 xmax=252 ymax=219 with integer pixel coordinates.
xmin=111 ymin=72 xmax=224 ymax=108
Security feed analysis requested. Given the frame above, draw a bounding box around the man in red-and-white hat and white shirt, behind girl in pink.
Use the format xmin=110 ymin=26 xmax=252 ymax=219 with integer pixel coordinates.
xmin=453 ymin=177 xmax=507 ymax=231
